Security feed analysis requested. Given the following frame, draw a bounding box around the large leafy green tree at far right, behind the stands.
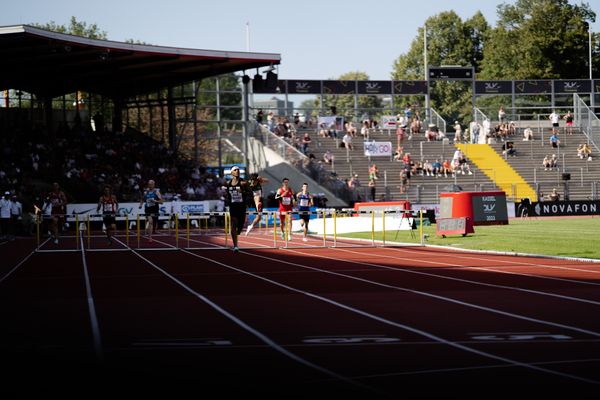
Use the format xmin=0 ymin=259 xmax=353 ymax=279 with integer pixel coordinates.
xmin=481 ymin=0 xmax=597 ymax=79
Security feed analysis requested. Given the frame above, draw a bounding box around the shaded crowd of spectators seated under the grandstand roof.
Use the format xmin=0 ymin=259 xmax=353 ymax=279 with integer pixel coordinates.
xmin=0 ymin=123 xmax=227 ymax=214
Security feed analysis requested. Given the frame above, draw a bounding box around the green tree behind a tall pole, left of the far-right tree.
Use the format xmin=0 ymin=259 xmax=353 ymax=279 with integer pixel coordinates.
xmin=392 ymin=11 xmax=489 ymax=121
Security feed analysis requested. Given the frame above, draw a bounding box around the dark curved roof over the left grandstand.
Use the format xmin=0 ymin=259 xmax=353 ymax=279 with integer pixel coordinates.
xmin=0 ymin=25 xmax=281 ymax=97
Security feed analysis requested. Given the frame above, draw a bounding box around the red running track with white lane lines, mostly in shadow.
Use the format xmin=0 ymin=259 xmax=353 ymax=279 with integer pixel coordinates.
xmin=0 ymin=235 xmax=600 ymax=398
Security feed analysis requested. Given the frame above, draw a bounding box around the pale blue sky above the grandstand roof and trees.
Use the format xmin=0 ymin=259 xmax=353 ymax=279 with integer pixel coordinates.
xmin=0 ymin=0 xmax=600 ymax=80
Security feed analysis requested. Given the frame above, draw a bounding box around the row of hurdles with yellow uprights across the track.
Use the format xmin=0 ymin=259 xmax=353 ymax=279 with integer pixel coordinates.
xmin=36 ymin=208 xmax=429 ymax=252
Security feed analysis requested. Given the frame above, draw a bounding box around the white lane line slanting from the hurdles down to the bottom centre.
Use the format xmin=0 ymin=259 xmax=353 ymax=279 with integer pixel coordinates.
xmin=116 ymin=241 xmax=377 ymax=392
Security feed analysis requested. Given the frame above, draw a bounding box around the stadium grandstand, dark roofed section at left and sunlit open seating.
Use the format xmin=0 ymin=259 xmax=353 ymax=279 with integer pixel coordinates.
xmin=0 ymin=26 xmax=600 ymax=247
